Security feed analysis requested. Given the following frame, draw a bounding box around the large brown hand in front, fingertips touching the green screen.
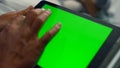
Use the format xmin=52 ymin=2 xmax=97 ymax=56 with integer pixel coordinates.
xmin=0 ymin=6 xmax=60 ymax=68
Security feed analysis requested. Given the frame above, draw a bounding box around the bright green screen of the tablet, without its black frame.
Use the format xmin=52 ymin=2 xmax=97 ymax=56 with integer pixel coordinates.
xmin=37 ymin=4 xmax=112 ymax=68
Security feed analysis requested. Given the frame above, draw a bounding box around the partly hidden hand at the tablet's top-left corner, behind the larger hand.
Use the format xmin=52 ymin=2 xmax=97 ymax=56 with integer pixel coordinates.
xmin=0 ymin=6 xmax=33 ymax=31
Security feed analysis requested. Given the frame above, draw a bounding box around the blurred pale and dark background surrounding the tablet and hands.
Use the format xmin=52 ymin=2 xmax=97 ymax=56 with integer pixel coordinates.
xmin=0 ymin=0 xmax=120 ymax=68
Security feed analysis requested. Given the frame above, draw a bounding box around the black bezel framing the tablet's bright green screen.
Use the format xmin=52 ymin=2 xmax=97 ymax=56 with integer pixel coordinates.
xmin=35 ymin=1 xmax=120 ymax=68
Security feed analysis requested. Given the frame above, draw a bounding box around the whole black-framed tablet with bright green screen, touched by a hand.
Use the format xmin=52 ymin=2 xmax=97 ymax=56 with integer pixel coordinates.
xmin=35 ymin=1 xmax=120 ymax=68
